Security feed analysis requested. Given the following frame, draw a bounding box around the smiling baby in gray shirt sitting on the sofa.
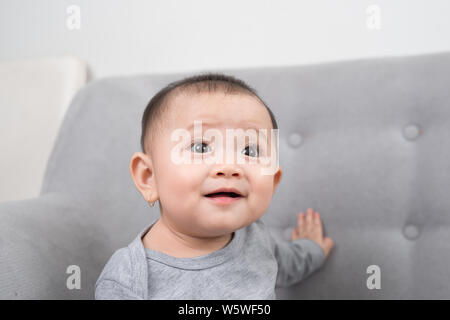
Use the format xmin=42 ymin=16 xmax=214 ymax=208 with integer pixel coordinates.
xmin=95 ymin=73 xmax=333 ymax=300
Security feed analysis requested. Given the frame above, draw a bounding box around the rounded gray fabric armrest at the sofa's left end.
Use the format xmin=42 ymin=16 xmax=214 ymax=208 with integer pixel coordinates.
xmin=0 ymin=193 xmax=103 ymax=299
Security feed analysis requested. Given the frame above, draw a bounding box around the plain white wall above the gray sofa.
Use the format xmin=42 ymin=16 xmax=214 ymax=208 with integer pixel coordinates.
xmin=0 ymin=0 xmax=450 ymax=79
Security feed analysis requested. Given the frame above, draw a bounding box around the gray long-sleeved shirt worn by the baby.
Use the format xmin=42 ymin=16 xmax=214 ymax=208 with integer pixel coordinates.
xmin=95 ymin=219 xmax=325 ymax=300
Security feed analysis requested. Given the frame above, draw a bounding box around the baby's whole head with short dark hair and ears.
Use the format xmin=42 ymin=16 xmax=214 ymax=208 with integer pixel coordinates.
xmin=130 ymin=74 xmax=282 ymax=237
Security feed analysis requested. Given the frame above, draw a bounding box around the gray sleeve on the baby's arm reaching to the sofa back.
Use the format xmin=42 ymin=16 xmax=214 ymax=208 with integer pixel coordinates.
xmin=267 ymin=226 xmax=325 ymax=288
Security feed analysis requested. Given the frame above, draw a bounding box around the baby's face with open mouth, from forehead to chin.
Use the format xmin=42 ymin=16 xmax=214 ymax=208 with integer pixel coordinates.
xmin=144 ymin=92 xmax=281 ymax=237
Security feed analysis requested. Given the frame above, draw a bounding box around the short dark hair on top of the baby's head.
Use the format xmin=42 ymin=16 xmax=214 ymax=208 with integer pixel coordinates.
xmin=141 ymin=73 xmax=278 ymax=157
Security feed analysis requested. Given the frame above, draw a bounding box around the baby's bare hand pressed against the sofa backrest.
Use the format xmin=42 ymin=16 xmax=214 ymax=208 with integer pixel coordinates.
xmin=291 ymin=208 xmax=334 ymax=258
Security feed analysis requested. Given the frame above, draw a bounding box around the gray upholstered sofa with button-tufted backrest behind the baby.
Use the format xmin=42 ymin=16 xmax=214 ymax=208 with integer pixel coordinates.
xmin=0 ymin=53 xmax=450 ymax=299
